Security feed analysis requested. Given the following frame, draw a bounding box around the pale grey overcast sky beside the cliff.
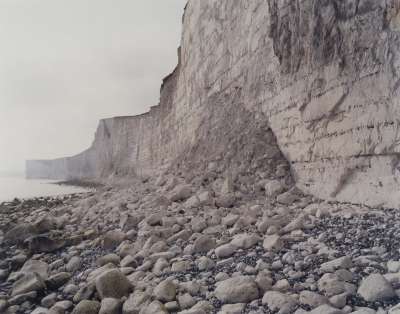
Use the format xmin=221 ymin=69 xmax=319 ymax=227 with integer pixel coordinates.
xmin=0 ymin=0 xmax=186 ymax=171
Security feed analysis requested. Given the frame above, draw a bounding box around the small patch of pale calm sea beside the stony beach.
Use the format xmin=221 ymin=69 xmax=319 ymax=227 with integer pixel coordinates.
xmin=0 ymin=176 xmax=88 ymax=202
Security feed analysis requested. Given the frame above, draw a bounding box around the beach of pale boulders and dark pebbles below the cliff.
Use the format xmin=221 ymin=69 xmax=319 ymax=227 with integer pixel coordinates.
xmin=0 ymin=176 xmax=400 ymax=314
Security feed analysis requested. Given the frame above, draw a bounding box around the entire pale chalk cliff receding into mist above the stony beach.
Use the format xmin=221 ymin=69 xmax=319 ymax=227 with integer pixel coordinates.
xmin=27 ymin=0 xmax=400 ymax=207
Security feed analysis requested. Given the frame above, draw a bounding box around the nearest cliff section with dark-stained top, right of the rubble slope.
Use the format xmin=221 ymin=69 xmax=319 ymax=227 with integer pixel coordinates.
xmin=263 ymin=1 xmax=400 ymax=207
